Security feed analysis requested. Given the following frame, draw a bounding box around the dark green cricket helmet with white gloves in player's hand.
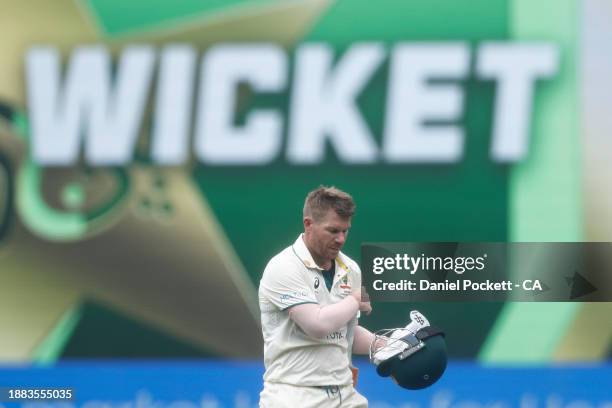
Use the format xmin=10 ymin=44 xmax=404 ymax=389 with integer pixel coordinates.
xmin=370 ymin=311 xmax=447 ymax=390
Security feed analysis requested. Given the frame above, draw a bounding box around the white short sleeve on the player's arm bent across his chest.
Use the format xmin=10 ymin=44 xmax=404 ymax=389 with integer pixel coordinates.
xmin=259 ymin=259 xmax=318 ymax=310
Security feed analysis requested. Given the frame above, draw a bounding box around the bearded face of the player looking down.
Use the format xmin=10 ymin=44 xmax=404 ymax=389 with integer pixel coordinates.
xmin=304 ymin=209 xmax=351 ymax=261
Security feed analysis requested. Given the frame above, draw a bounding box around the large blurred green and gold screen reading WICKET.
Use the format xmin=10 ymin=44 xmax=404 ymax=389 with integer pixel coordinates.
xmin=0 ymin=0 xmax=612 ymax=406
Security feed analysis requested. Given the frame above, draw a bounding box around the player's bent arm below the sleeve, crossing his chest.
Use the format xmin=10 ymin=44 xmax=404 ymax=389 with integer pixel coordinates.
xmin=289 ymin=296 xmax=359 ymax=338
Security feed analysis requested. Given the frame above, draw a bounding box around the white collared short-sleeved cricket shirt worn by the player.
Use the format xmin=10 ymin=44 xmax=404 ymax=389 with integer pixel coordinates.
xmin=259 ymin=235 xmax=361 ymax=386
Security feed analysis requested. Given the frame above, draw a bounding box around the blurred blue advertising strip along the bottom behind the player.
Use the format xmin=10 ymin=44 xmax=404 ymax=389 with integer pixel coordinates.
xmin=0 ymin=361 xmax=612 ymax=408
